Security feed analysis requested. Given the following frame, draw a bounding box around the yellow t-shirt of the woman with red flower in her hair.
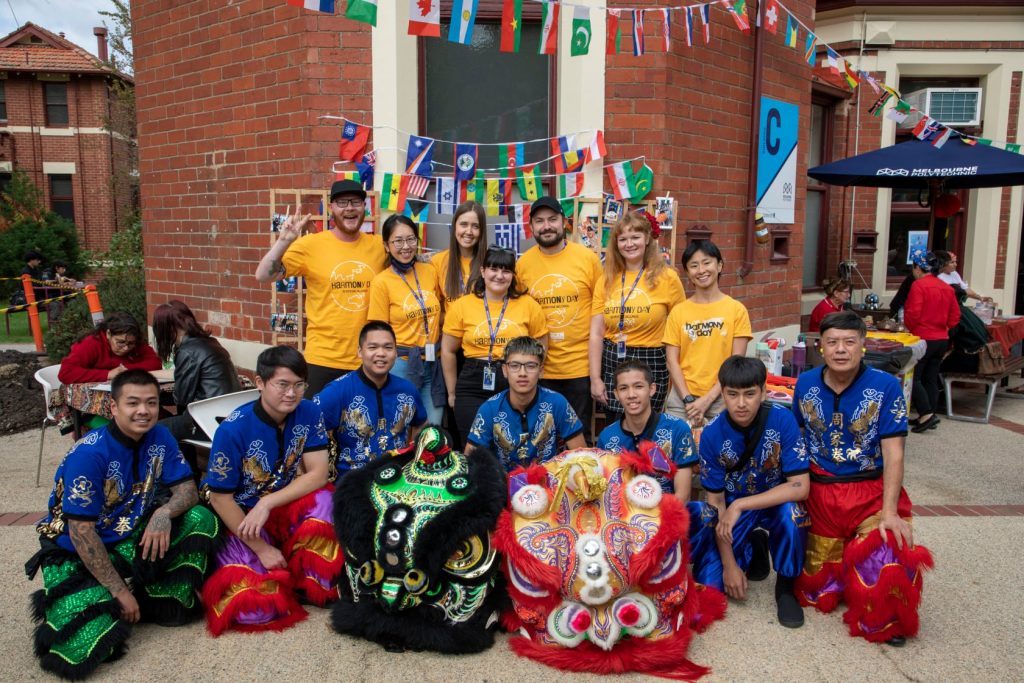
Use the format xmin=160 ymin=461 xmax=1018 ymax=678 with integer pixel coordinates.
xmin=591 ymin=266 xmax=686 ymax=348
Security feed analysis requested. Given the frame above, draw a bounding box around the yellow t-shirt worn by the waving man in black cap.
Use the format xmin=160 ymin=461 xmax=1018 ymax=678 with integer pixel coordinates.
xmin=282 ymin=230 xmax=387 ymax=370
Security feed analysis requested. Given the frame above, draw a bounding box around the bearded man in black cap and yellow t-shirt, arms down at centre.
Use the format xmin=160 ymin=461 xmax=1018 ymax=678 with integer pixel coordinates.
xmin=516 ymin=197 xmax=601 ymax=442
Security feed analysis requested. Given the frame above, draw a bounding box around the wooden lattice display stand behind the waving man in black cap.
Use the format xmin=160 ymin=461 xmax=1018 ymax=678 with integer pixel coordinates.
xmin=270 ymin=189 xmax=380 ymax=351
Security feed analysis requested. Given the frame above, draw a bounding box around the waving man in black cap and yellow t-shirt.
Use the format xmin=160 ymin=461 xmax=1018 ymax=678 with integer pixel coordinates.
xmin=256 ymin=180 xmax=387 ymax=397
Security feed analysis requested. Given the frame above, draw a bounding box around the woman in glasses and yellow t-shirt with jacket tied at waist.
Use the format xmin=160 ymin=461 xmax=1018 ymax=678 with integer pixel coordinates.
xmin=367 ymin=214 xmax=444 ymax=425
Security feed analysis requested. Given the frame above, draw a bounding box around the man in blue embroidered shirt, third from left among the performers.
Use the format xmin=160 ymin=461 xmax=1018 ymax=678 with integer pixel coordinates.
xmin=313 ymin=321 xmax=427 ymax=476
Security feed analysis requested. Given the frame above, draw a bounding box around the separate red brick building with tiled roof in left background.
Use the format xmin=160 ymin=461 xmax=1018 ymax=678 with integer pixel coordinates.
xmin=0 ymin=23 xmax=135 ymax=251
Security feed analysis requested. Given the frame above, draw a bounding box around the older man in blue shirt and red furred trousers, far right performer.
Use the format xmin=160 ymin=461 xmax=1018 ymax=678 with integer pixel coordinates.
xmin=793 ymin=311 xmax=933 ymax=646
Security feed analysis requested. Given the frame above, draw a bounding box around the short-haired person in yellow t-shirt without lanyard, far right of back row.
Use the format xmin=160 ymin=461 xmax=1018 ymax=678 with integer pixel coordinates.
xmin=665 ymin=240 xmax=753 ymax=429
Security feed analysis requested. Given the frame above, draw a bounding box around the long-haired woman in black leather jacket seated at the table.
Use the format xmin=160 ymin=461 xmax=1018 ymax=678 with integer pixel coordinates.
xmin=153 ymin=299 xmax=242 ymax=466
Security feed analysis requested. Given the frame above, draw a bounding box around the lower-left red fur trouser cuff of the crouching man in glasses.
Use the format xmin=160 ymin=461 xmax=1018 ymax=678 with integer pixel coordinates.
xmin=203 ymin=565 xmax=308 ymax=637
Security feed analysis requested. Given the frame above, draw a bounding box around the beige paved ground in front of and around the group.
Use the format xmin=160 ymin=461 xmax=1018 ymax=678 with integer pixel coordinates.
xmin=0 ymin=382 xmax=1024 ymax=682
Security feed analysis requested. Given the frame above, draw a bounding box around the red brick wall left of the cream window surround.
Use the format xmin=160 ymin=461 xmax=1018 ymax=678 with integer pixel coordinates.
xmin=131 ymin=0 xmax=374 ymax=342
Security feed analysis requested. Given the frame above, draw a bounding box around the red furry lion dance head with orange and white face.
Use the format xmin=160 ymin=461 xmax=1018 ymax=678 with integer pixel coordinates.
xmin=496 ymin=449 xmax=725 ymax=680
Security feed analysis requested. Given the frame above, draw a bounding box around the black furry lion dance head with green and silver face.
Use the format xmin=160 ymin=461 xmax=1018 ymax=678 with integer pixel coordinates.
xmin=332 ymin=426 xmax=506 ymax=653
